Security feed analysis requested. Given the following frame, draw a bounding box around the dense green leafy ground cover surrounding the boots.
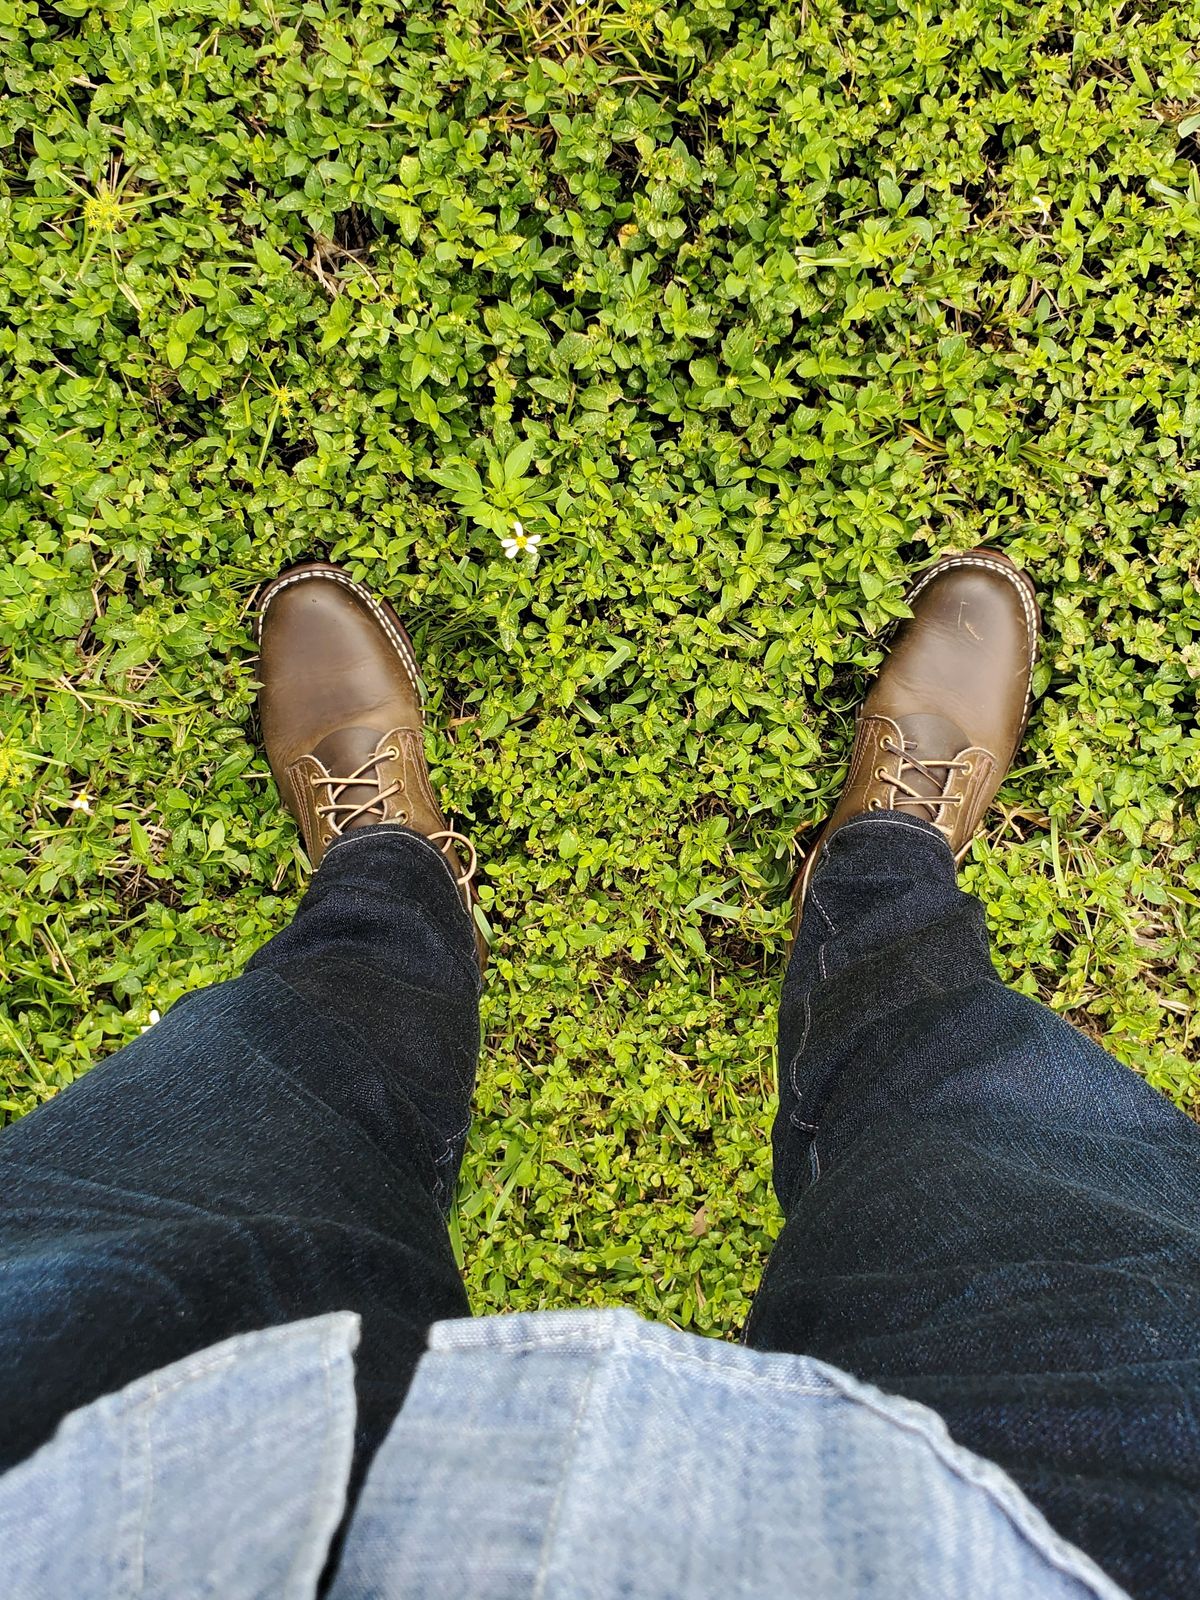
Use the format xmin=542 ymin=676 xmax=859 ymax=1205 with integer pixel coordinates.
xmin=0 ymin=0 xmax=1200 ymax=1334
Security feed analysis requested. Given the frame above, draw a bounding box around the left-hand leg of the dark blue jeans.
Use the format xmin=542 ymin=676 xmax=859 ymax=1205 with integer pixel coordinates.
xmin=0 ymin=826 xmax=480 ymax=1470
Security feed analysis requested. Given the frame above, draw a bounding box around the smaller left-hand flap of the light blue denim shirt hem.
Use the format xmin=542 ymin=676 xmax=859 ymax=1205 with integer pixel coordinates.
xmin=0 ymin=1315 xmax=358 ymax=1600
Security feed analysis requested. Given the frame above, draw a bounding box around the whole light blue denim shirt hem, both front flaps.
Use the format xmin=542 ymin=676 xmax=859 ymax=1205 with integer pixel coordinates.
xmin=0 ymin=1310 xmax=1123 ymax=1600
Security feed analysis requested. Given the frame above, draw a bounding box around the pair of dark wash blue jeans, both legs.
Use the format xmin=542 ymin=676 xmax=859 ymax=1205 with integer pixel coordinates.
xmin=0 ymin=813 xmax=1200 ymax=1600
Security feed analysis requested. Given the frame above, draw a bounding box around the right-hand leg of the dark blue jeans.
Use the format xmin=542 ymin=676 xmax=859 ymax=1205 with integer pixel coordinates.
xmin=747 ymin=813 xmax=1200 ymax=1600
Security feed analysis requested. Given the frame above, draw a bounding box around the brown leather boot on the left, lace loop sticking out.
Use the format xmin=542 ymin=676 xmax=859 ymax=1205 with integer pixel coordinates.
xmin=259 ymin=562 xmax=486 ymax=965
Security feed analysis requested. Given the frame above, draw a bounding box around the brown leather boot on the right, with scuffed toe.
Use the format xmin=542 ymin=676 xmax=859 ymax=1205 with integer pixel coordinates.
xmin=794 ymin=550 xmax=1040 ymax=930
